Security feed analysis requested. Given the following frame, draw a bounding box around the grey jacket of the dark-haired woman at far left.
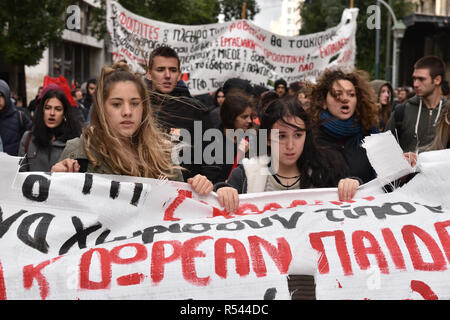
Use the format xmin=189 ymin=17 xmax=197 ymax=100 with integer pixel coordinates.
xmin=19 ymin=131 xmax=66 ymax=172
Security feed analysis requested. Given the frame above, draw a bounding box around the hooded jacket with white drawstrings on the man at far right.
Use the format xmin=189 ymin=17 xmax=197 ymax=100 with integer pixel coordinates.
xmin=386 ymin=95 xmax=446 ymax=152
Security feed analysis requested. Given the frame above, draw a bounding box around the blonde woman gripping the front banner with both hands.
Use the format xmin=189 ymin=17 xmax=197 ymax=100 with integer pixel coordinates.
xmin=52 ymin=62 xmax=212 ymax=194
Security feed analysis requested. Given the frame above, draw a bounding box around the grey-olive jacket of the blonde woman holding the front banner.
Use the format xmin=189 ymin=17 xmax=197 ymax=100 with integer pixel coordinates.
xmin=59 ymin=138 xmax=183 ymax=181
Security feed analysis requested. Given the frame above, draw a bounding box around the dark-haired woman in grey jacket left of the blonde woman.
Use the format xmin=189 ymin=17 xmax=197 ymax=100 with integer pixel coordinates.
xmin=19 ymin=89 xmax=81 ymax=172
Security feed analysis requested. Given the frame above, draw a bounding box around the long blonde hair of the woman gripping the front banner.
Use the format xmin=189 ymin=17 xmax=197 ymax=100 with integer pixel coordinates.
xmin=83 ymin=61 xmax=174 ymax=178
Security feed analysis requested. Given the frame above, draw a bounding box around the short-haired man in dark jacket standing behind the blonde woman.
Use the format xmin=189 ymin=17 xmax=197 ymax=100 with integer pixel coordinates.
xmin=145 ymin=46 xmax=212 ymax=181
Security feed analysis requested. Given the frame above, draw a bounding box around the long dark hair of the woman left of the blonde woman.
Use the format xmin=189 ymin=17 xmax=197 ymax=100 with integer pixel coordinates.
xmin=32 ymin=89 xmax=81 ymax=147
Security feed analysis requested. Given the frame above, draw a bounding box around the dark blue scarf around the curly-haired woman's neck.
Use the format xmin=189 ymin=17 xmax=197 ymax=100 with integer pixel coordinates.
xmin=320 ymin=110 xmax=378 ymax=147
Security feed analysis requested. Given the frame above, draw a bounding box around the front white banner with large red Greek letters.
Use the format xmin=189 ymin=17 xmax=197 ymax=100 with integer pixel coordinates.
xmin=0 ymin=150 xmax=450 ymax=300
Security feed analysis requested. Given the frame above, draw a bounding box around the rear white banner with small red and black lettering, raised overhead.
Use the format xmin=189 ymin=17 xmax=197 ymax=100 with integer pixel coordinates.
xmin=107 ymin=1 xmax=358 ymax=94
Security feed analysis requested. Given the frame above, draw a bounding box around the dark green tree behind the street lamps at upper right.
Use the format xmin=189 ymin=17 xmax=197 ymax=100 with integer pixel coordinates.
xmin=300 ymin=0 xmax=412 ymax=79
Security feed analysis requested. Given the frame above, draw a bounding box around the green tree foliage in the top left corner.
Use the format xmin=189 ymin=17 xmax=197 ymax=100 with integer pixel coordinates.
xmin=0 ymin=0 xmax=70 ymax=66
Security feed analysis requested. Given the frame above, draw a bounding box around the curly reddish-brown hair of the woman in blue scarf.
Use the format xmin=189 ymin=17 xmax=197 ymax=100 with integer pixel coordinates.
xmin=309 ymin=69 xmax=379 ymax=132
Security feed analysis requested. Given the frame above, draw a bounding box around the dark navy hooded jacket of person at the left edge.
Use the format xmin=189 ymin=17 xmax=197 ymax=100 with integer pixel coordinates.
xmin=0 ymin=80 xmax=31 ymax=156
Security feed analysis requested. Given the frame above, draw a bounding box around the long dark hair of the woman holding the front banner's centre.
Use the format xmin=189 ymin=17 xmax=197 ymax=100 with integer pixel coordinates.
xmin=259 ymin=96 xmax=345 ymax=189
